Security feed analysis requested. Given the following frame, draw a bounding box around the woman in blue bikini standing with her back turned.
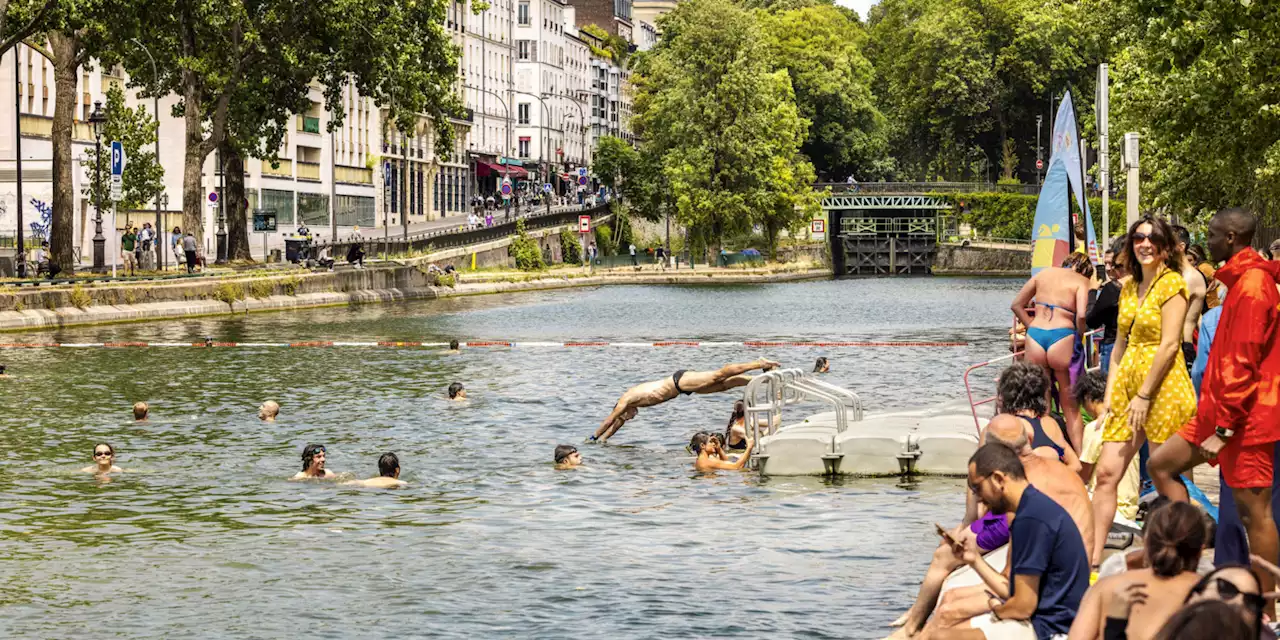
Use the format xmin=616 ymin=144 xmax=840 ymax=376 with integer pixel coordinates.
xmin=1010 ymin=253 xmax=1089 ymax=453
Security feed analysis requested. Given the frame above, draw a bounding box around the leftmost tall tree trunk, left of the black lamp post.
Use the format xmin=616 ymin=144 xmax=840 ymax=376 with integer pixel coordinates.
xmin=49 ymin=31 xmax=79 ymax=275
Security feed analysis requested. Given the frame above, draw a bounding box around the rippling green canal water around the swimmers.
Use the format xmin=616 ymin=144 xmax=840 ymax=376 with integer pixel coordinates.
xmin=0 ymin=278 xmax=1019 ymax=639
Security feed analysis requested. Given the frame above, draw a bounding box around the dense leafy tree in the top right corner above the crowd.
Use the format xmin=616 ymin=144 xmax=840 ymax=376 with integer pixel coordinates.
xmin=1112 ymin=0 xmax=1280 ymax=220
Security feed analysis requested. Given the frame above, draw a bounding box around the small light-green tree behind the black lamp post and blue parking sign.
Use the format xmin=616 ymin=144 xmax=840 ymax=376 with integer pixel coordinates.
xmin=81 ymin=84 xmax=164 ymax=212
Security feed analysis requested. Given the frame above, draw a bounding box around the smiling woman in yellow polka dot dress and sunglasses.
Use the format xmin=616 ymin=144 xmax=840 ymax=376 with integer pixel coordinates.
xmin=1092 ymin=215 xmax=1196 ymax=566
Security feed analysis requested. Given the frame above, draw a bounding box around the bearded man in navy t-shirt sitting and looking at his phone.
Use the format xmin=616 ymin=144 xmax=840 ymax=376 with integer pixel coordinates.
xmin=941 ymin=443 xmax=1089 ymax=640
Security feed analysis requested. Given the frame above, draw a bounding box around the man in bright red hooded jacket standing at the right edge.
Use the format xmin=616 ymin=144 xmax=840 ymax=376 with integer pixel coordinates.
xmin=1148 ymin=209 xmax=1280 ymax=606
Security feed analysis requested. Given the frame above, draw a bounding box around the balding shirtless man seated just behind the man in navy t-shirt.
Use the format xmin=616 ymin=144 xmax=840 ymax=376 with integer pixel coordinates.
xmin=890 ymin=413 xmax=1093 ymax=637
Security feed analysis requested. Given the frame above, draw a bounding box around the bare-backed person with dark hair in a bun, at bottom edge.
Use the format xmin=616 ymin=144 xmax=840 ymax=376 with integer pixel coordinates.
xmin=1068 ymin=502 xmax=1208 ymax=640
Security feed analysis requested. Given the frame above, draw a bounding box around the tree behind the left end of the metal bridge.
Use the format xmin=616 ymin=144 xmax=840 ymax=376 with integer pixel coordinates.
xmin=762 ymin=3 xmax=893 ymax=182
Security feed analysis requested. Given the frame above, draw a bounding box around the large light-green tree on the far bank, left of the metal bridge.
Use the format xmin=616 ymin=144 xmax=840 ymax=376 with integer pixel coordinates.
xmin=634 ymin=0 xmax=813 ymax=248
